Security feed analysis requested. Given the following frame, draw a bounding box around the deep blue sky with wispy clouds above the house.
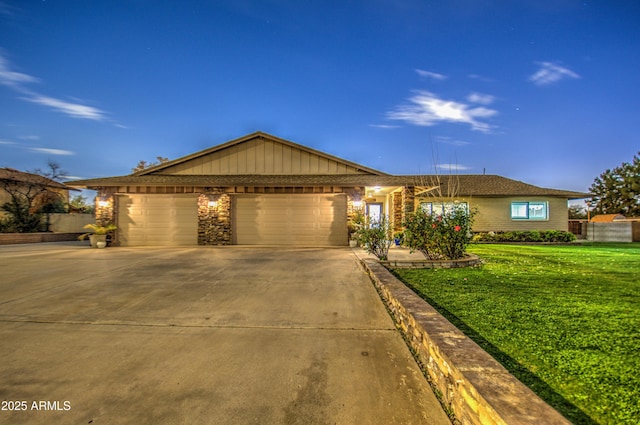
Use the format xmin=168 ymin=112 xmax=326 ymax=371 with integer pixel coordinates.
xmin=0 ymin=0 xmax=640 ymax=191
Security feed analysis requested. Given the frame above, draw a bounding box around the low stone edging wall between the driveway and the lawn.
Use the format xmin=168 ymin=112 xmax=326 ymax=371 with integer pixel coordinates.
xmin=360 ymin=259 xmax=571 ymax=425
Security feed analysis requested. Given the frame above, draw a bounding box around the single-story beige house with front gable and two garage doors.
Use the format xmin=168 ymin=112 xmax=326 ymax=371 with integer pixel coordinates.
xmin=68 ymin=132 xmax=588 ymax=246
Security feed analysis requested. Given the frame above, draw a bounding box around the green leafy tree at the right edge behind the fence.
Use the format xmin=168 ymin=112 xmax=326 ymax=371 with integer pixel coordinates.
xmin=589 ymin=152 xmax=640 ymax=217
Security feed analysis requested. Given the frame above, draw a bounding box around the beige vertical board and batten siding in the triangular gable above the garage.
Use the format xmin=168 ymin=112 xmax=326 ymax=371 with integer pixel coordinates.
xmin=162 ymin=138 xmax=364 ymax=175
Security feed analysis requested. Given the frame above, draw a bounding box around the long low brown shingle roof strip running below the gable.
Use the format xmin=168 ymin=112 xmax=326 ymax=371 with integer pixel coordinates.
xmin=67 ymin=174 xmax=589 ymax=199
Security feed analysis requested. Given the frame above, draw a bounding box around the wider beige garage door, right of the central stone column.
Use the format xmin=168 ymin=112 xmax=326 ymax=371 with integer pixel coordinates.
xmin=233 ymin=194 xmax=347 ymax=246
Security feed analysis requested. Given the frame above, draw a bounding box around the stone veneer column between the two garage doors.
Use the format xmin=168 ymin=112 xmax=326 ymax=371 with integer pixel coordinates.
xmin=198 ymin=189 xmax=231 ymax=245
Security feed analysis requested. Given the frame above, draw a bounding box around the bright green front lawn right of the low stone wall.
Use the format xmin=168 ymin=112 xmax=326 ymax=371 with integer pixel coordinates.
xmin=395 ymin=244 xmax=640 ymax=425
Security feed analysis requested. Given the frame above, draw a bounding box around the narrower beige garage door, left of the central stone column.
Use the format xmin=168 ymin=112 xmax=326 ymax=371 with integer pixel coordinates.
xmin=118 ymin=195 xmax=198 ymax=246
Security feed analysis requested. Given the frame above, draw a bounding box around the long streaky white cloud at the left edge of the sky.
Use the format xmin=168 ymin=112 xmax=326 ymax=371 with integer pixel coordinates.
xmin=0 ymin=50 xmax=106 ymax=121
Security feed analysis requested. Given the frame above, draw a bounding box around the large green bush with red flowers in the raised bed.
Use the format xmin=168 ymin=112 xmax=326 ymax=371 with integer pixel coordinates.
xmin=404 ymin=204 xmax=475 ymax=260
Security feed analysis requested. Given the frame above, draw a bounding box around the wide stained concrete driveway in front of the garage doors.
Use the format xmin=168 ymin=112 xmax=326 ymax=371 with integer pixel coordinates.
xmin=0 ymin=243 xmax=449 ymax=425
